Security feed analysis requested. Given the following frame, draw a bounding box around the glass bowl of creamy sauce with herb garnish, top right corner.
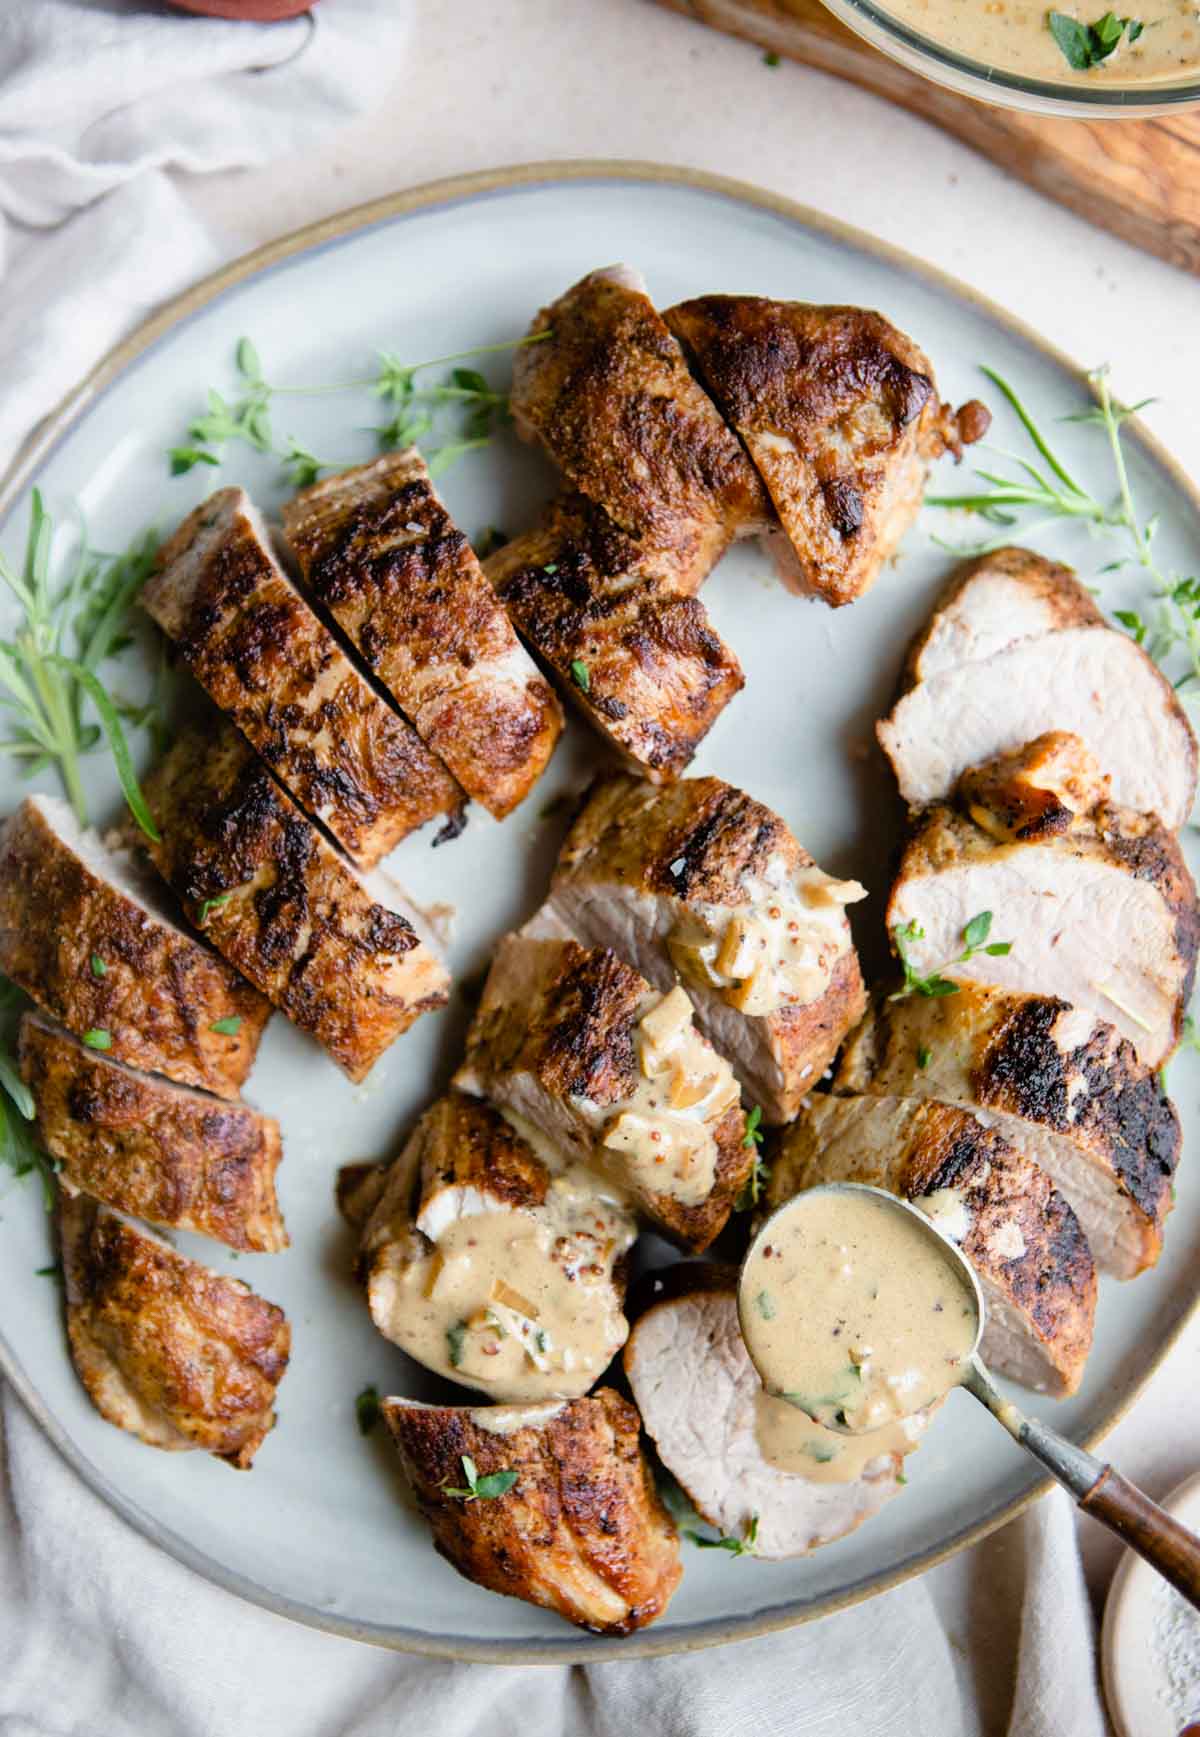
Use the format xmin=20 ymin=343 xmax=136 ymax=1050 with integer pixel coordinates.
xmin=812 ymin=0 xmax=1200 ymax=120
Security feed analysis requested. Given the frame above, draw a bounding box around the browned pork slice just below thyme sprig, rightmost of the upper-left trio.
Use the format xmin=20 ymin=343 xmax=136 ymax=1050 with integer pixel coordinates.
xmin=283 ymin=446 xmax=563 ymax=820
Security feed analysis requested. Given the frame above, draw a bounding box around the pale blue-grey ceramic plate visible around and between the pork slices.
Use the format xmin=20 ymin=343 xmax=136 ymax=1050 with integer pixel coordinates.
xmin=0 ymin=165 xmax=1200 ymax=1661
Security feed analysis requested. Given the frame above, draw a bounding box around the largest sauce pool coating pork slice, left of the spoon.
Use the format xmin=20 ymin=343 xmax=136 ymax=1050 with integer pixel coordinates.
xmin=389 ymin=1167 xmax=636 ymax=1400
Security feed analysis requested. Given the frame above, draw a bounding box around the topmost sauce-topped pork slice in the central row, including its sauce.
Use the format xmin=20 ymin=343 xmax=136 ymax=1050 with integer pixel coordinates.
xmin=549 ymin=773 xmax=865 ymax=1122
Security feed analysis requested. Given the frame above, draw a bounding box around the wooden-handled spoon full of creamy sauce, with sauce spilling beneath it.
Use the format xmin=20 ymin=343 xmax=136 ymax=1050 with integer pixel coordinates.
xmin=738 ymin=1183 xmax=1200 ymax=1608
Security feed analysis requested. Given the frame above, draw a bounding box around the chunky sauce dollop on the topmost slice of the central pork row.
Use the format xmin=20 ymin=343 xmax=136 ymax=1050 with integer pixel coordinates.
xmin=667 ymin=856 xmax=867 ymax=1016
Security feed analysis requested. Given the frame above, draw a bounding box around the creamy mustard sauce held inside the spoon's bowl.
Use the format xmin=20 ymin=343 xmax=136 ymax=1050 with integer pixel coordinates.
xmin=738 ymin=1190 xmax=978 ymax=1431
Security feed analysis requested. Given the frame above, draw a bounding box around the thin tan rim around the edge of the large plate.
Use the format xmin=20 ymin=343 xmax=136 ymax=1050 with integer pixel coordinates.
xmin=0 ymin=158 xmax=1200 ymax=1664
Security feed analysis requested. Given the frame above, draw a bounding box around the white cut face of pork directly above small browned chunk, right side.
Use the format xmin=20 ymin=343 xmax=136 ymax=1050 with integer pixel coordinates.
xmin=875 ymin=627 xmax=1197 ymax=829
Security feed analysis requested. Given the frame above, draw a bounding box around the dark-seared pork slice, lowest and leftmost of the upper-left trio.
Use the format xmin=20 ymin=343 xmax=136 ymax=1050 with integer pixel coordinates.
xmin=146 ymin=724 xmax=448 ymax=1080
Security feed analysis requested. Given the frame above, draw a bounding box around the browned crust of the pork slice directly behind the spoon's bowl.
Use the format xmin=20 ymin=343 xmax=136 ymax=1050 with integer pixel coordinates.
xmin=769 ymin=1098 xmax=1096 ymax=1393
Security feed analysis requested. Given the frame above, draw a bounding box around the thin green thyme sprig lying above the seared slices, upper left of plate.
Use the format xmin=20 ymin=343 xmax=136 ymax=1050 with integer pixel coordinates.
xmin=167 ymin=332 xmax=549 ymax=488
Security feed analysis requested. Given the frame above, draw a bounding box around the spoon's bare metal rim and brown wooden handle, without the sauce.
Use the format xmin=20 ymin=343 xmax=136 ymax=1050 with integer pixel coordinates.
xmin=738 ymin=1183 xmax=1200 ymax=1610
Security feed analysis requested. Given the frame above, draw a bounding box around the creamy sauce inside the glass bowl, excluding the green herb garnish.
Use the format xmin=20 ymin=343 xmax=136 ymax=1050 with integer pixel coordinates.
xmin=879 ymin=0 xmax=1200 ymax=85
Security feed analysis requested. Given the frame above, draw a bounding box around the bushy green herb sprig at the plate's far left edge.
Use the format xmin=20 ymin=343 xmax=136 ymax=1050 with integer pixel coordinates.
xmin=0 ymin=488 xmax=158 ymax=839
